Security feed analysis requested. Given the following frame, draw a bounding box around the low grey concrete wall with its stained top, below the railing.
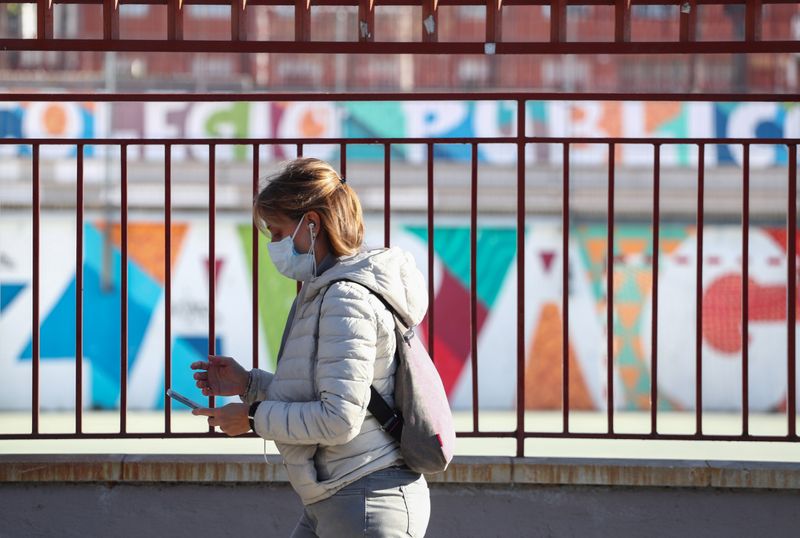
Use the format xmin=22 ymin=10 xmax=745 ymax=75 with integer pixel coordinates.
xmin=0 ymin=456 xmax=800 ymax=538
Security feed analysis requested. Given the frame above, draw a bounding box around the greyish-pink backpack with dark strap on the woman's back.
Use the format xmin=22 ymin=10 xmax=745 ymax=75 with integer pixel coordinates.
xmin=331 ymin=280 xmax=456 ymax=474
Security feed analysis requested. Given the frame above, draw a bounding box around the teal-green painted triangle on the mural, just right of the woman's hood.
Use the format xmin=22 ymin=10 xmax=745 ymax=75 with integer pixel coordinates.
xmin=406 ymin=226 xmax=517 ymax=308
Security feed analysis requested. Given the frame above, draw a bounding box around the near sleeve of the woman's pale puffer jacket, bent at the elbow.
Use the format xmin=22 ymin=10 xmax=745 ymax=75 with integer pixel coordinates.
xmin=254 ymin=282 xmax=377 ymax=445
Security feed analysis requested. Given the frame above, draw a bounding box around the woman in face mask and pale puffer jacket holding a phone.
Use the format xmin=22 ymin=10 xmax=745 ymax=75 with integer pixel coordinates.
xmin=192 ymin=159 xmax=430 ymax=538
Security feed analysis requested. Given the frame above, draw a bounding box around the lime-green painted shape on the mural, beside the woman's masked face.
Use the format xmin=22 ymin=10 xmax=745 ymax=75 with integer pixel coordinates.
xmin=241 ymin=224 xmax=297 ymax=369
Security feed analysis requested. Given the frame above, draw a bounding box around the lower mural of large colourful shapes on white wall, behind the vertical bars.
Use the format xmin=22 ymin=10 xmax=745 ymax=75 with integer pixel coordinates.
xmin=0 ymin=214 xmax=798 ymax=411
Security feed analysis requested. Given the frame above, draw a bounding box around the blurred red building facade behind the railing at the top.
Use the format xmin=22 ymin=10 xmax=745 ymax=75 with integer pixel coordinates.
xmin=0 ymin=4 xmax=800 ymax=92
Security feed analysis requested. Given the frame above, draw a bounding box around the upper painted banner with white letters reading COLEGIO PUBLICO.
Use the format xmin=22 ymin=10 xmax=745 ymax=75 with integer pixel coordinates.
xmin=0 ymin=101 xmax=800 ymax=168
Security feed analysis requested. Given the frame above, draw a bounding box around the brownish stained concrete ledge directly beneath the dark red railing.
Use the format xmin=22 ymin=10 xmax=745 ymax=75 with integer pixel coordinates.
xmin=0 ymin=454 xmax=800 ymax=490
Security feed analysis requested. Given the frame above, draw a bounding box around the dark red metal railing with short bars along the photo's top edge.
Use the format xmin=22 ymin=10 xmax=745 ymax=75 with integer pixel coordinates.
xmin=0 ymin=0 xmax=800 ymax=54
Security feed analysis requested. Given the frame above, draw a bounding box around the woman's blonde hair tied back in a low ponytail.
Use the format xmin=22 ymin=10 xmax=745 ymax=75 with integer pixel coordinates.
xmin=253 ymin=158 xmax=364 ymax=257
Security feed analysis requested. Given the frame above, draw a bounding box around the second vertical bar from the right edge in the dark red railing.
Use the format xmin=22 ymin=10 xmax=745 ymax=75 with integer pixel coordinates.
xmin=742 ymin=144 xmax=750 ymax=436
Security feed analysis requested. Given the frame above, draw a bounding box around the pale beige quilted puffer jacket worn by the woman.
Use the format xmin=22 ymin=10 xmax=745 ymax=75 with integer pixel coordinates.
xmin=244 ymin=248 xmax=428 ymax=504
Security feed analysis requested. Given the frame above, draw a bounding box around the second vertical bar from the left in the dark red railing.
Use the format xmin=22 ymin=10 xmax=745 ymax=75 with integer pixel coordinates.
xmin=75 ymin=144 xmax=83 ymax=433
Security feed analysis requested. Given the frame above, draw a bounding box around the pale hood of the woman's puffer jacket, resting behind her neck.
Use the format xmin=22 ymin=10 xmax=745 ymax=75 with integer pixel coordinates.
xmin=303 ymin=247 xmax=428 ymax=327
